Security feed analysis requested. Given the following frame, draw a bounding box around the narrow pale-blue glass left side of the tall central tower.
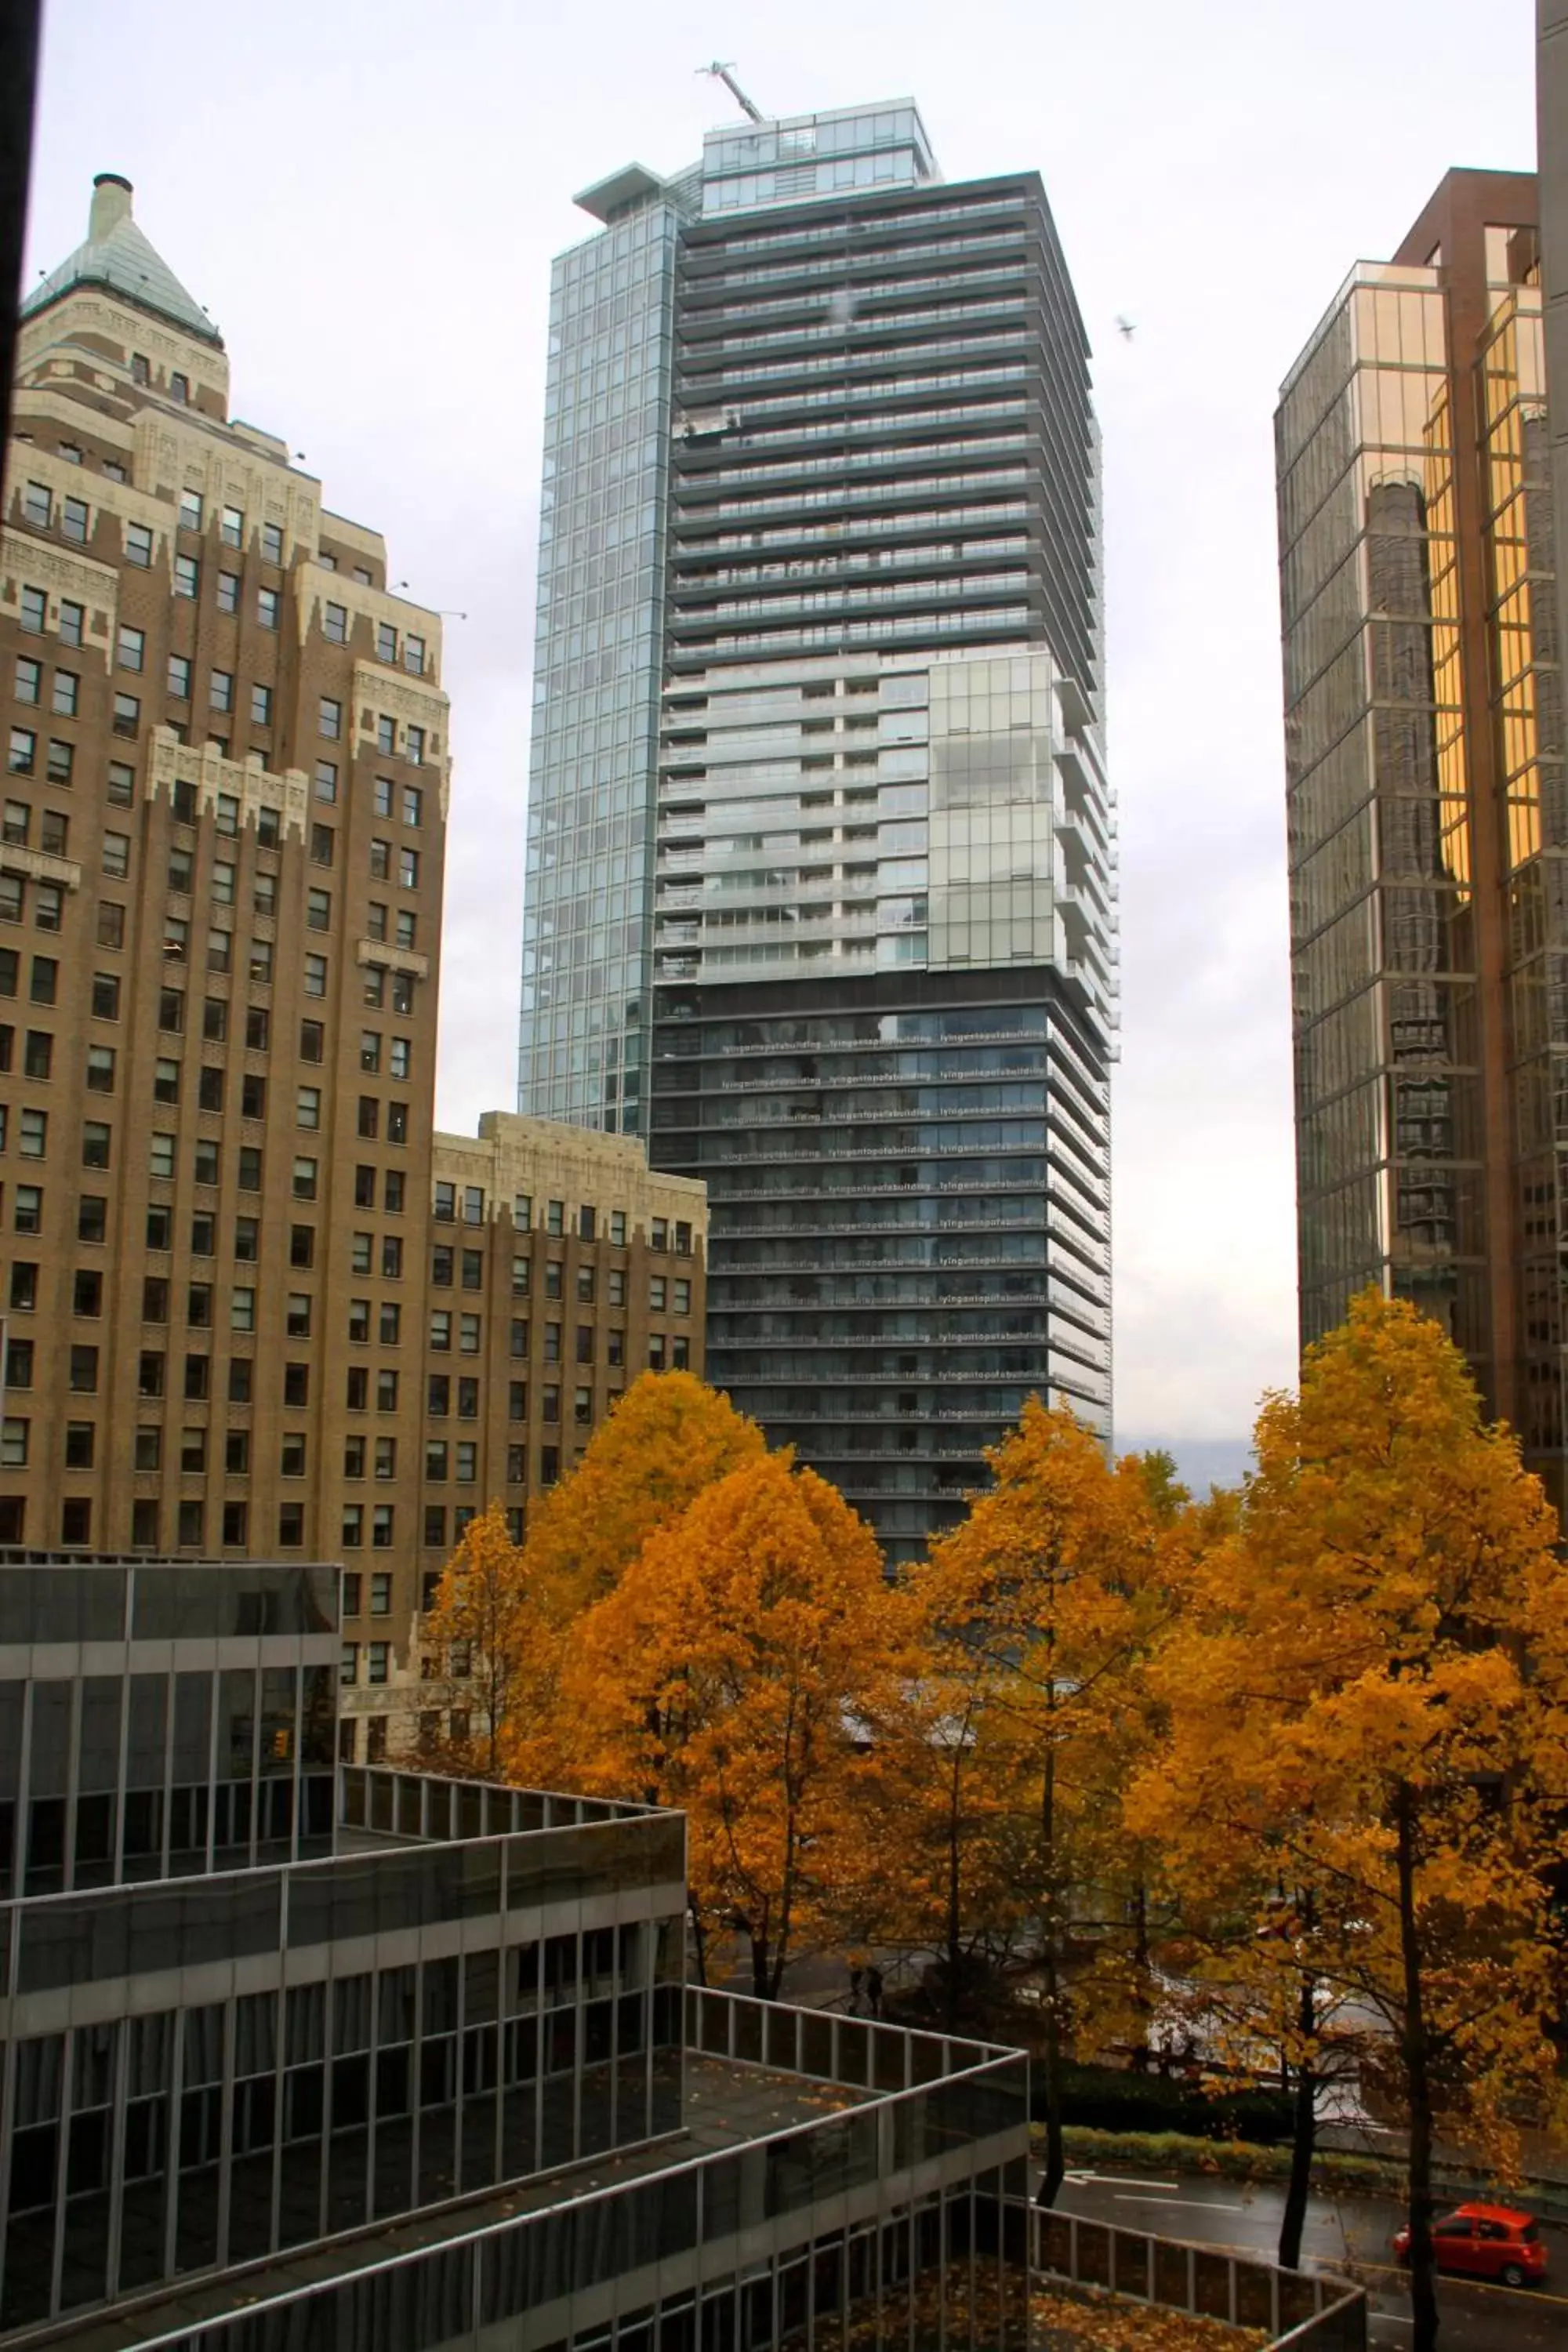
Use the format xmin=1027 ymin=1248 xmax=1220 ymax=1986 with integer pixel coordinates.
xmin=517 ymin=195 xmax=682 ymax=1134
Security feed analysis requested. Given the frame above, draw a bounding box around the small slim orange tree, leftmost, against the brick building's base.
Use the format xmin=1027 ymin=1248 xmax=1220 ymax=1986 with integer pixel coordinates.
xmin=421 ymin=1503 xmax=527 ymax=1780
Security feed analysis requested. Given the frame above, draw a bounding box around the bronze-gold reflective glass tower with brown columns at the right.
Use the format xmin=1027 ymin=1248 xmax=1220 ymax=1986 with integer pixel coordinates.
xmin=1276 ymin=172 xmax=1568 ymax=1501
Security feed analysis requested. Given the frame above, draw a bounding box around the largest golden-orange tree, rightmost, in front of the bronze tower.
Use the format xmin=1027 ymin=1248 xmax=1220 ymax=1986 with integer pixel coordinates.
xmin=1128 ymin=1291 xmax=1568 ymax=2352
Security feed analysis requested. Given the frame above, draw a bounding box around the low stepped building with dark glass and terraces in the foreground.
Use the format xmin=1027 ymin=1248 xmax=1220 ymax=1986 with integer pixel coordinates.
xmin=0 ymin=1559 xmax=1027 ymax=2352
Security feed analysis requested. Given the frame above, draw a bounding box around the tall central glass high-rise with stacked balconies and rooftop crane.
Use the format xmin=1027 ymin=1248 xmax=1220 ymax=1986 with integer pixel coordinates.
xmin=522 ymin=101 xmax=1116 ymax=1555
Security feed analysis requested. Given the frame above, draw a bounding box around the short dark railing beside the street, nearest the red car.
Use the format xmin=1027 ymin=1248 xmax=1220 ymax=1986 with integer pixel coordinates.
xmin=1029 ymin=2206 xmax=1366 ymax=2352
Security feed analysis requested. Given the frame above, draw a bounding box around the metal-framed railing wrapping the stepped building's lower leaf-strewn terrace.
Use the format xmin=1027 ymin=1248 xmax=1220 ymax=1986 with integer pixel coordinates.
xmin=59 ymin=1987 xmax=1027 ymax=2352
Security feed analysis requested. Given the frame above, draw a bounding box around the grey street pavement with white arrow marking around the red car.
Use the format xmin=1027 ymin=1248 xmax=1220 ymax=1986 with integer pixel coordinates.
xmin=1058 ymin=2166 xmax=1568 ymax=2352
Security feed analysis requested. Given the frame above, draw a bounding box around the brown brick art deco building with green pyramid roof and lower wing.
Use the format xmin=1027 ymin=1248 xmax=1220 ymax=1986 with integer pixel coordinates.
xmin=0 ymin=174 xmax=706 ymax=1748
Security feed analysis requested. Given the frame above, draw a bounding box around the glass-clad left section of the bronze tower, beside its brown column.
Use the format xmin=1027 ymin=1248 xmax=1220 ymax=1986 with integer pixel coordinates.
xmin=1276 ymin=263 xmax=1490 ymax=1367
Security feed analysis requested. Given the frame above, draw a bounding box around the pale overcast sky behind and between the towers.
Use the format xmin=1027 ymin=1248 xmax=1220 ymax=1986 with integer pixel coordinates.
xmin=28 ymin=0 xmax=1535 ymax=1461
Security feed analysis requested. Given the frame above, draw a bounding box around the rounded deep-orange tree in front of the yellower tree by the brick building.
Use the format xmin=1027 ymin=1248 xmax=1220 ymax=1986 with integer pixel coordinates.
xmin=562 ymin=1454 xmax=916 ymax=1999
